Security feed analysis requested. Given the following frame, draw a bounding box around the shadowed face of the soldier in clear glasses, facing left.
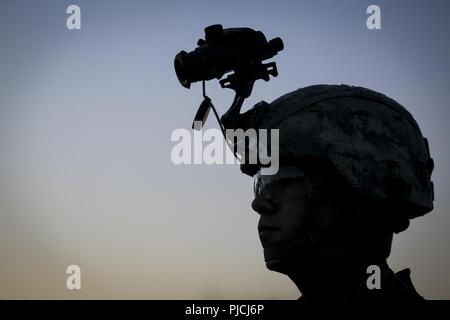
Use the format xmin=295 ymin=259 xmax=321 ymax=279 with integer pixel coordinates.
xmin=252 ymin=178 xmax=309 ymax=270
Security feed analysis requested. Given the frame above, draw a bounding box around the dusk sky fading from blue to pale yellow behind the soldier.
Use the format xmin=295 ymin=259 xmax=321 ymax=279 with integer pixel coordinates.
xmin=0 ymin=0 xmax=450 ymax=299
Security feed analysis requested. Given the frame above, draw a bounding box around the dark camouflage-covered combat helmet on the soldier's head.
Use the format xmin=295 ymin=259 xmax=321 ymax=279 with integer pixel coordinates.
xmin=241 ymin=85 xmax=434 ymax=219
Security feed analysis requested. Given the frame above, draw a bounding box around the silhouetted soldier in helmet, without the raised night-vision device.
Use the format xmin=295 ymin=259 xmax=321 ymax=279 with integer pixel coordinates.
xmin=246 ymin=85 xmax=433 ymax=300
